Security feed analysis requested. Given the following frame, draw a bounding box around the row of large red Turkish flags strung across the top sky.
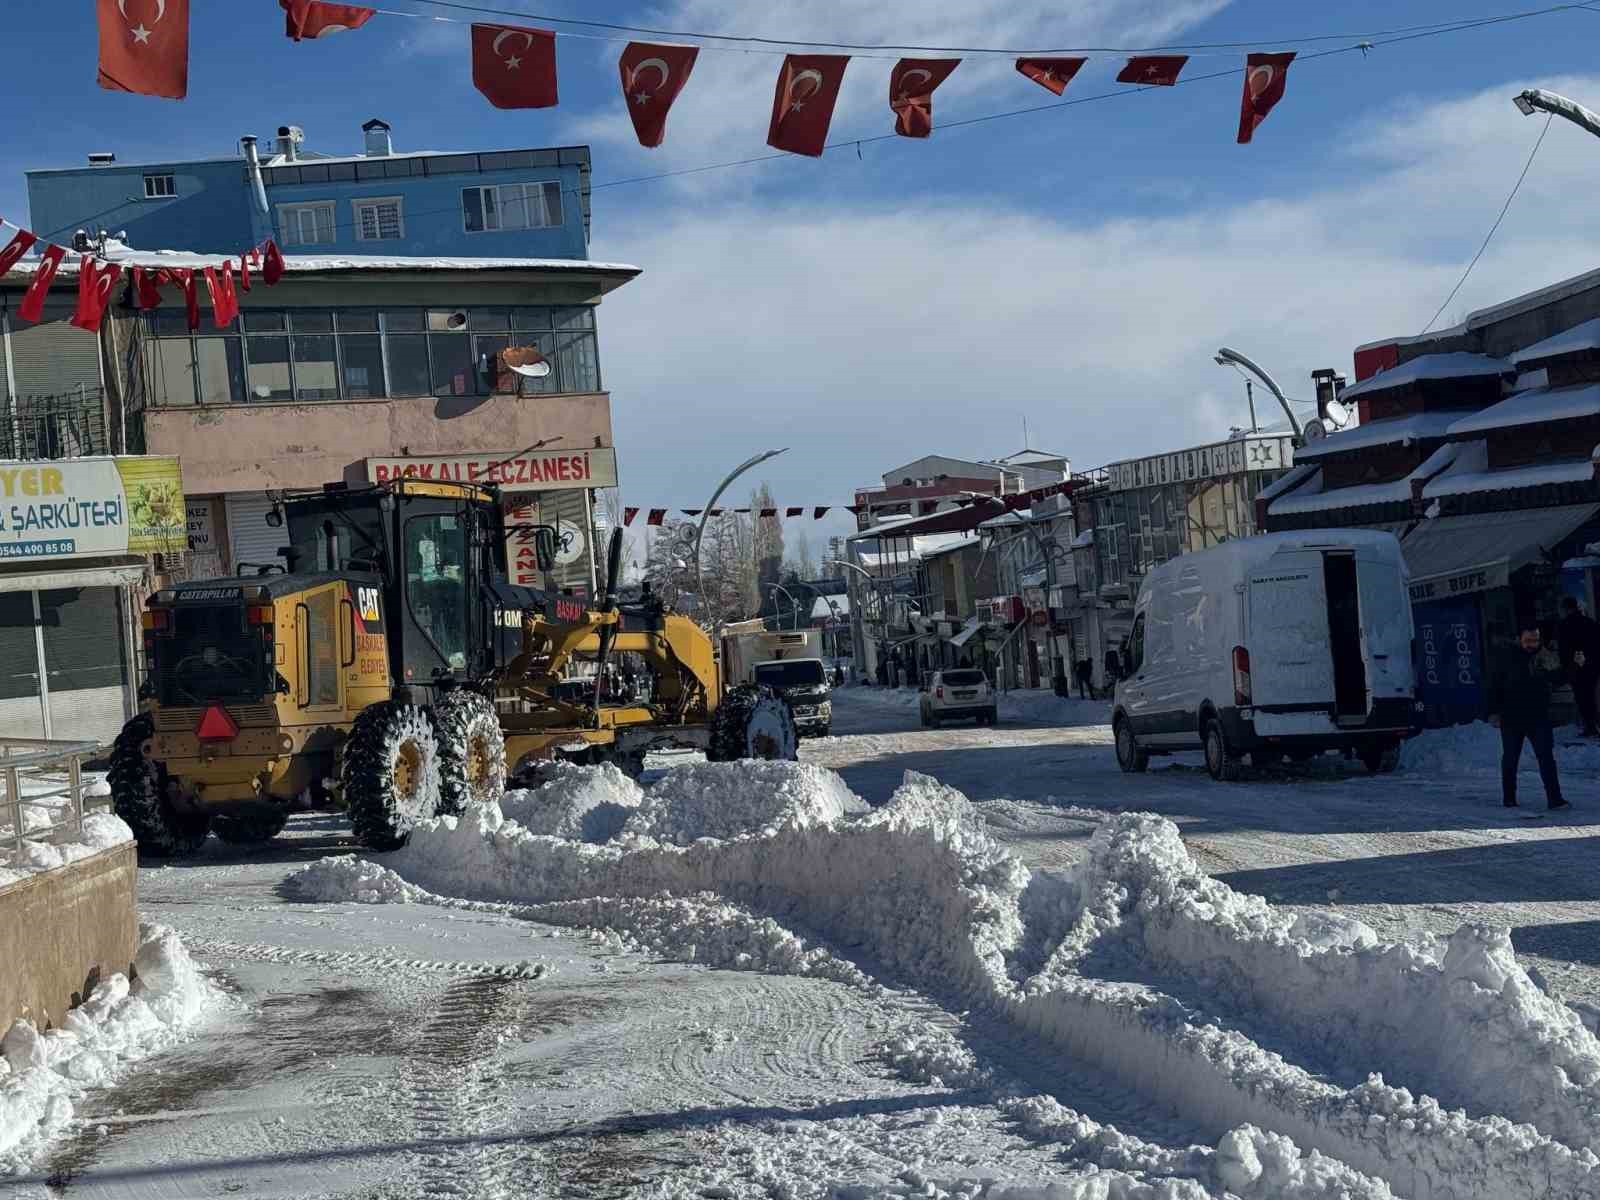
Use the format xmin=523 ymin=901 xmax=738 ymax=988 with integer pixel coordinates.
xmin=96 ymin=0 xmax=1294 ymax=157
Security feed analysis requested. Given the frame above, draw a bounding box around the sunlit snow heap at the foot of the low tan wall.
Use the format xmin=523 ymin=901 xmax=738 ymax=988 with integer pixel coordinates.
xmin=0 ymin=925 xmax=221 ymax=1171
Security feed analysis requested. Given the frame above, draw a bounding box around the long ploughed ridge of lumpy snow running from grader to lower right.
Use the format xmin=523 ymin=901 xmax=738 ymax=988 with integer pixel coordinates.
xmin=291 ymin=763 xmax=1600 ymax=1200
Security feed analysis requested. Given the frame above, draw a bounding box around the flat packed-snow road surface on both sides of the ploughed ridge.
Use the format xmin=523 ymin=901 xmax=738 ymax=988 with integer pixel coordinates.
xmin=0 ymin=690 xmax=1600 ymax=1200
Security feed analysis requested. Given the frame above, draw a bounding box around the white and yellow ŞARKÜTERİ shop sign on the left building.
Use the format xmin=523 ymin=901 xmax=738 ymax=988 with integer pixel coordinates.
xmin=0 ymin=456 xmax=187 ymax=560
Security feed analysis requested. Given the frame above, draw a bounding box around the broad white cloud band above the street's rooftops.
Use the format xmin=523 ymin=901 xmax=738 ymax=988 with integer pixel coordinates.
xmin=595 ymin=70 xmax=1600 ymax=504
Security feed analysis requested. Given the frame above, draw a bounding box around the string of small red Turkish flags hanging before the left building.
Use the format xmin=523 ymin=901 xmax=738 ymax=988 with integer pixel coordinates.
xmin=0 ymin=219 xmax=283 ymax=333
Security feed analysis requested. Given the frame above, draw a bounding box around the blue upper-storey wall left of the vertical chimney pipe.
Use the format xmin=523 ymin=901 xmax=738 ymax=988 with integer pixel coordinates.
xmin=27 ymin=157 xmax=259 ymax=254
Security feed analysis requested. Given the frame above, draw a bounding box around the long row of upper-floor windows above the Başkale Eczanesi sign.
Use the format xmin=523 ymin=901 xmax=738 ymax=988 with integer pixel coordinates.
xmin=144 ymin=306 xmax=600 ymax=408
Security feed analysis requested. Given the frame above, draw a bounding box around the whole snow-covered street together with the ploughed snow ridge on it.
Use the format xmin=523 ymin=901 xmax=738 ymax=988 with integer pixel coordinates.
xmin=0 ymin=691 xmax=1600 ymax=1200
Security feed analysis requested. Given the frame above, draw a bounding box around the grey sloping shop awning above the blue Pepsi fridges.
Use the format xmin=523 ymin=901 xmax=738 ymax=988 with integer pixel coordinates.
xmin=1400 ymin=504 xmax=1600 ymax=603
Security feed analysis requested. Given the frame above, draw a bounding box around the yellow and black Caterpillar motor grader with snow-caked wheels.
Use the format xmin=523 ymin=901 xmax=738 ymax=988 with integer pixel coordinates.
xmin=110 ymin=480 xmax=798 ymax=854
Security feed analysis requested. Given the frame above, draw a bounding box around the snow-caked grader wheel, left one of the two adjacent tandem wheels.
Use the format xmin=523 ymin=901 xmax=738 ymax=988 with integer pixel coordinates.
xmin=339 ymin=701 xmax=438 ymax=850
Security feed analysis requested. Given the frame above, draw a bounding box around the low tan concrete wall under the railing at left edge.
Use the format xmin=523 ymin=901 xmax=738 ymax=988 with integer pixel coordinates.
xmin=0 ymin=842 xmax=139 ymax=1030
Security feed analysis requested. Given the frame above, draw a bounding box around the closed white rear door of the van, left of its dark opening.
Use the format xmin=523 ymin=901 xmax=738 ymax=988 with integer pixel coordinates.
xmin=1246 ymin=550 xmax=1334 ymax=710
